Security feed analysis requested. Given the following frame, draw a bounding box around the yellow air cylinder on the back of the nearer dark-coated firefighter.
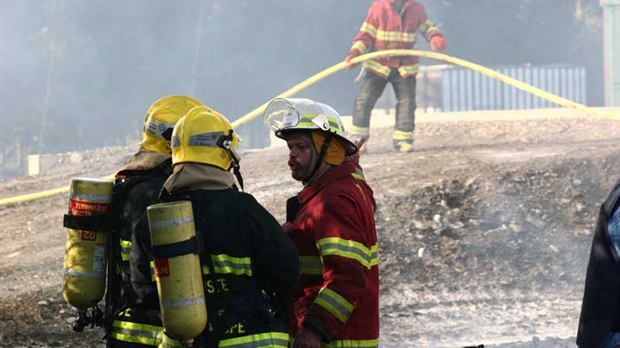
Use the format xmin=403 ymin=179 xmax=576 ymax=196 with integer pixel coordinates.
xmin=147 ymin=201 xmax=207 ymax=341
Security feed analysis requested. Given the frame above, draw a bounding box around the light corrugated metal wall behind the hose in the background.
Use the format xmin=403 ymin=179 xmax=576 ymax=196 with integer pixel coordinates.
xmin=416 ymin=65 xmax=586 ymax=112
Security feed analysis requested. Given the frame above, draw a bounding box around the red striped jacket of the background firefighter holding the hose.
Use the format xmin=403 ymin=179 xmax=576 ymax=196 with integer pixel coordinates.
xmin=349 ymin=0 xmax=441 ymax=78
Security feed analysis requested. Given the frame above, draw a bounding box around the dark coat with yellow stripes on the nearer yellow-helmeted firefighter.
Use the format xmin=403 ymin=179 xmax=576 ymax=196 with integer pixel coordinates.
xmin=132 ymin=188 xmax=300 ymax=347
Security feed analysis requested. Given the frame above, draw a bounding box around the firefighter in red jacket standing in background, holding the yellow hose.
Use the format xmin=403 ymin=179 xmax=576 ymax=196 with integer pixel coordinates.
xmin=345 ymin=0 xmax=446 ymax=153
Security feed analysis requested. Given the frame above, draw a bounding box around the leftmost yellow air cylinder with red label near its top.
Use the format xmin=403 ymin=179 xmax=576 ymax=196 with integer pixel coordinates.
xmin=62 ymin=178 xmax=113 ymax=312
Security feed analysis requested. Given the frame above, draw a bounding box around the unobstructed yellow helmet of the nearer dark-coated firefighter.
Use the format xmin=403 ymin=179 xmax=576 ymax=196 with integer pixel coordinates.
xmin=172 ymin=106 xmax=240 ymax=170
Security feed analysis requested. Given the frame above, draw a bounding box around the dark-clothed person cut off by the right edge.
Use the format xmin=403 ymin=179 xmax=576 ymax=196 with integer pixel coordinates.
xmin=577 ymin=180 xmax=620 ymax=348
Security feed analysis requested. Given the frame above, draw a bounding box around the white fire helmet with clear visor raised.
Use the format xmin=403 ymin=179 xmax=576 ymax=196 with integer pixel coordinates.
xmin=263 ymin=98 xmax=357 ymax=155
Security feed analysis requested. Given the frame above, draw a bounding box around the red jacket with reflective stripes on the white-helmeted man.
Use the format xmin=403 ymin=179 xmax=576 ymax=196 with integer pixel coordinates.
xmin=284 ymin=162 xmax=379 ymax=347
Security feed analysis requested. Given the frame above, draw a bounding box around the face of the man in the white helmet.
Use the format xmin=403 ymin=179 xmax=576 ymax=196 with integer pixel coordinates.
xmin=286 ymin=133 xmax=317 ymax=181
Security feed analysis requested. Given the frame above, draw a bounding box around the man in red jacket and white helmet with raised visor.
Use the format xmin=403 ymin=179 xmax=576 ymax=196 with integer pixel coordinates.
xmin=264 ymin=98 xmax=379 ymax=348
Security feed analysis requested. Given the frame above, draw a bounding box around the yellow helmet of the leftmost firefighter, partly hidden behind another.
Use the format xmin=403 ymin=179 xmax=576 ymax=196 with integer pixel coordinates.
xmin=140 ymin=95 xmax=204 ymax=155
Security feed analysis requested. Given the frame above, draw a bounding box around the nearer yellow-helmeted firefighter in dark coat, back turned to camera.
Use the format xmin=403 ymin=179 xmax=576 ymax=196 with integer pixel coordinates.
xmin=131 ymin=107 xmax=300 ymax=348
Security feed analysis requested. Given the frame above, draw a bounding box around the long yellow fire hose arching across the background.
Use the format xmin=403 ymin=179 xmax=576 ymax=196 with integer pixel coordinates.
xmin=0 ymin=50 xmax=620 ymax=206
